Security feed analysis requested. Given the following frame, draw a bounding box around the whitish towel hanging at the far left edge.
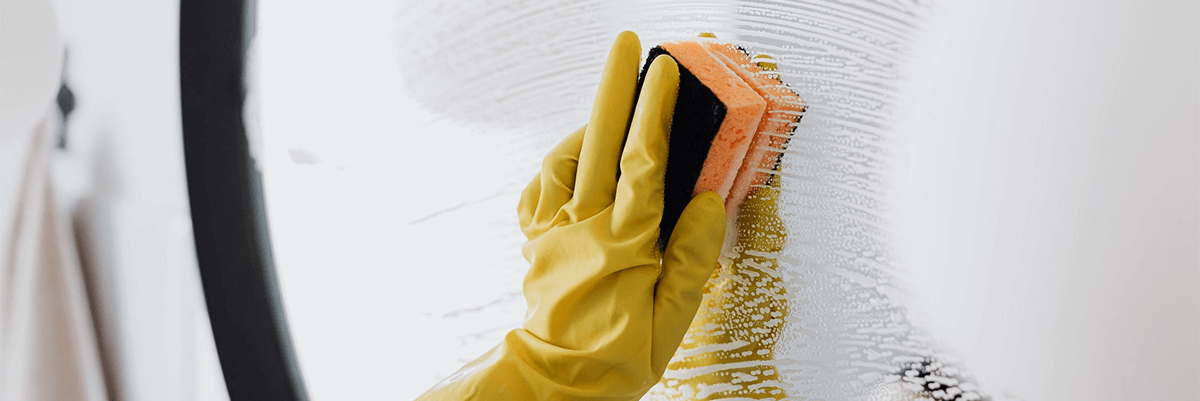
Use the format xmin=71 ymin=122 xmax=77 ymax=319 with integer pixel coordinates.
xmin=0 ymin=122 xmax=107 ymax=401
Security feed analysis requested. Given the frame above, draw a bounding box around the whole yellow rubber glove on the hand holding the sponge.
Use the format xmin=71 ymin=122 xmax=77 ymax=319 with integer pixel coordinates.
xmin=419 ymin=31 xmax=725 ymax=400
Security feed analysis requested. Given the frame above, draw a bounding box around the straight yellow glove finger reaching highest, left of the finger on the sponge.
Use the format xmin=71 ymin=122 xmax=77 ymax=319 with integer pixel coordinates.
xmin=568 ymin=31 xmax=642 ymax=221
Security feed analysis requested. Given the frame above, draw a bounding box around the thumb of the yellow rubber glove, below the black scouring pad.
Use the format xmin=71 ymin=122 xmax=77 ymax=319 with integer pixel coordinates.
xmin=650 ymin=192 xmax=725 ymax=373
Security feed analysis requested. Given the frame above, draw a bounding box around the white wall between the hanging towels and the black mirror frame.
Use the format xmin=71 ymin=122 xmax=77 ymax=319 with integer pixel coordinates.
xmin=53 ymin=0 xmax=227 ymax=401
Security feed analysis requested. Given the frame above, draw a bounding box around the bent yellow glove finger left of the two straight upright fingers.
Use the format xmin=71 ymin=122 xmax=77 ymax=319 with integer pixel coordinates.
xmin=522 ymin=127 xmax=587 ymax=238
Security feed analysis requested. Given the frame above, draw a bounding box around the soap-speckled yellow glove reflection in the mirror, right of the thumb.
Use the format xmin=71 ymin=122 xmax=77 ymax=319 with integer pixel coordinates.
xmin=652 ymin=175 xmax=787 ymax=400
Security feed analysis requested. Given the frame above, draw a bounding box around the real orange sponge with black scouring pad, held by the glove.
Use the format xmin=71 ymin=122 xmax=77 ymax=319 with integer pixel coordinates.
xmin=641 ymin=41 xmax=767 ymax=249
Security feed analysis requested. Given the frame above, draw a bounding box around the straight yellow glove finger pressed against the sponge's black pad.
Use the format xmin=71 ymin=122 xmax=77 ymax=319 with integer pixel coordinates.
xmin=613 ymin=55 xmax=679 ymax=243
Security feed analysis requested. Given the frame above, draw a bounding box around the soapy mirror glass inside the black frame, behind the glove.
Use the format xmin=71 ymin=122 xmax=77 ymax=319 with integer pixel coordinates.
xmin=216 ymin=0 xmax=1196 ymax=400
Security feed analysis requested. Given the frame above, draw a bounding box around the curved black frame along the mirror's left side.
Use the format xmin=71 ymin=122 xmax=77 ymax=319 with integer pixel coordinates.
xmin=179 ymin=0 xmax=308 ymax=401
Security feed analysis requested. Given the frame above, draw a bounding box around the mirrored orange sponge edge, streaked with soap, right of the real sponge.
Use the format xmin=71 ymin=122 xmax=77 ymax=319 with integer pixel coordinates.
xmin=702 ymin=41 xmax=805 ymax=221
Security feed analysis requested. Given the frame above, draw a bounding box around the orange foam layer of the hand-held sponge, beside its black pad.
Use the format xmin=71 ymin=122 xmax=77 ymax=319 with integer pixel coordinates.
xmin=660 ymin=41 xmax=767 ymax=202
